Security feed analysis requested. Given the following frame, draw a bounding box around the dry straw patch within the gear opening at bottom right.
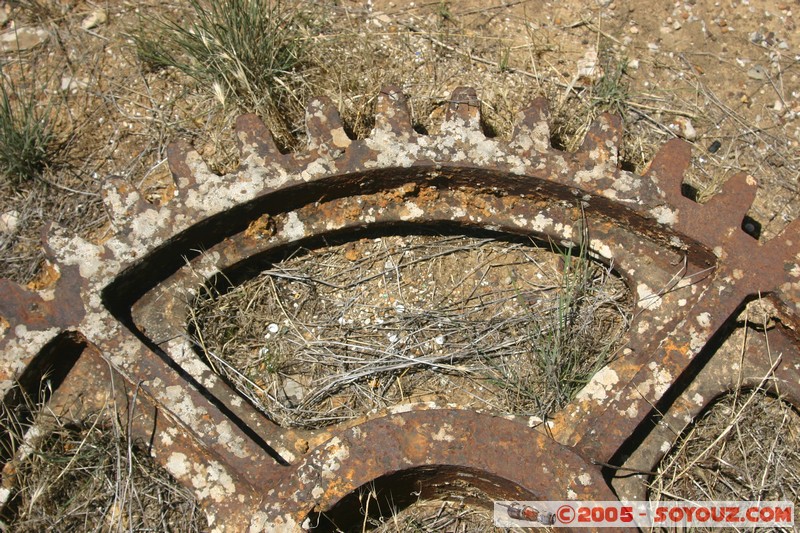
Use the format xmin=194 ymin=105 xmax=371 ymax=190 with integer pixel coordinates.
xmin=651 ymin=389 xmax=800 ymax=520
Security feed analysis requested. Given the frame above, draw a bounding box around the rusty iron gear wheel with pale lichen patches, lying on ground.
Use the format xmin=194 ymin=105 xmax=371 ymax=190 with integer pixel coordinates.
xmin=0 ymin=87 xmax=800 ymax=531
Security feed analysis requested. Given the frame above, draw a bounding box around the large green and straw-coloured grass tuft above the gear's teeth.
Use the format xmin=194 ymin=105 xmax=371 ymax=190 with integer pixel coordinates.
xmin=133 ymin=0 xmax=304 ymax=133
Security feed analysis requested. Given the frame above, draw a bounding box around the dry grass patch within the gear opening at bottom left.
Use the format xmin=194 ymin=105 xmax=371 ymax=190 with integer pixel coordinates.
xmin=0 ymin=388 xmax=206 ymax=533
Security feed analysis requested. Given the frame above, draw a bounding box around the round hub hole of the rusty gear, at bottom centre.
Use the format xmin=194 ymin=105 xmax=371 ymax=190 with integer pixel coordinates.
xmin=305 ymin=466 xmax=534 ymax=533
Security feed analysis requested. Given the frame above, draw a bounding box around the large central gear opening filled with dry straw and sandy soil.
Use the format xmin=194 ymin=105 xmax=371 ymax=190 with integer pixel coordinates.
xmin=189 ymin=224 xmax=632 ymax=428
